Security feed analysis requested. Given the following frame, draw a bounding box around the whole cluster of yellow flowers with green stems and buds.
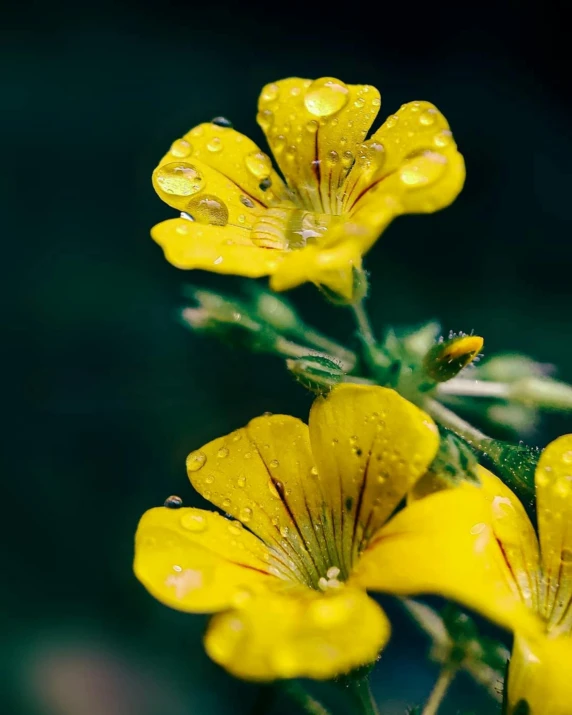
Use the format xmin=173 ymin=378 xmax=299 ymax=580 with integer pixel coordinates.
xmin=134 ymin=77 xmax=572 ymax=715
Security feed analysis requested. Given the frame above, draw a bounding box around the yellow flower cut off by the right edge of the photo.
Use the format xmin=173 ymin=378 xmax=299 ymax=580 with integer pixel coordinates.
xmin=458 ymin=435 xmax=572 ymax=715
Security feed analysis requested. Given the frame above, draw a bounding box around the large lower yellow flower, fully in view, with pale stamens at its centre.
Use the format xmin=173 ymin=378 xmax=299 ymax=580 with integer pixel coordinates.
xmin=134 ymin=385 xmax=528 ymax=680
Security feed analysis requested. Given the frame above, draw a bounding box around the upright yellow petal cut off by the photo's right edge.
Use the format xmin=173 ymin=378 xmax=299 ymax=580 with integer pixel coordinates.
xmin=535 ymin=434 xmax=572 ymax=632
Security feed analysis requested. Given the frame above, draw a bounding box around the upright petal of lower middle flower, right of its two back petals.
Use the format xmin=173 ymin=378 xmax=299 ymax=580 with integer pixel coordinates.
xmin=310 ymin=385 xmax=439 ymax=565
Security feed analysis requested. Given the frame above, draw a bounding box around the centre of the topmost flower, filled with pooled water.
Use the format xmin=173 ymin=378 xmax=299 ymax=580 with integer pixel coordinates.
xmin=251 ymin=207 xmax=334 ymax=251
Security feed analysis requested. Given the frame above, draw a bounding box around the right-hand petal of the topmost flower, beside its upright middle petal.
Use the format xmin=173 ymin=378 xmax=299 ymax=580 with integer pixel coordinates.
xmin=360 ymin=102 xmax=465 ymax=213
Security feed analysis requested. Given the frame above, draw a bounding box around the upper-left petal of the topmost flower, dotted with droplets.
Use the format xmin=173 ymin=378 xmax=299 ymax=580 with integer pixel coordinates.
xmin=153 ymin=122 xmax=289 ymax=207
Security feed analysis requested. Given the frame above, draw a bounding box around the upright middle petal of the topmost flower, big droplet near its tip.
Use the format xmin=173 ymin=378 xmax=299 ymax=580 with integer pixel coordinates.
xmin=257 ymin=77 xmax=381 ymax=214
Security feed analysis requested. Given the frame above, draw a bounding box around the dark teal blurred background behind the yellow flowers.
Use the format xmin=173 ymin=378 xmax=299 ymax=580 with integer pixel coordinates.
xmin=4 ymin=0 xmax=572 ymax=715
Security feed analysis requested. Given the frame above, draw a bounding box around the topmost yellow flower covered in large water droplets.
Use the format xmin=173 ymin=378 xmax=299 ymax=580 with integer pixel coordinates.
xmin=151 ymin=77 xmax=465 ymax=299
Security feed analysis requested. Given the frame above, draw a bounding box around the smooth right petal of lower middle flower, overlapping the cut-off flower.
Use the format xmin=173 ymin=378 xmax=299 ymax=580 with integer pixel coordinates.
xmin=353 ymin=488 xmax=540 ymax=632
